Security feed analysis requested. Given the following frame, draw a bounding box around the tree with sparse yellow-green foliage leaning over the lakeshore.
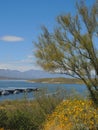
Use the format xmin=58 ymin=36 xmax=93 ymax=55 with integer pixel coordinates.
xmin=35 ymin=2 xmax=98 ymax=103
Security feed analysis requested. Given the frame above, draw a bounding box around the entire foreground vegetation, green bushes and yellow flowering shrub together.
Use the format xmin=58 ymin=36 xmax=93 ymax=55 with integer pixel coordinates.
xmin=0 ymin=90 xmax=98 ymax=130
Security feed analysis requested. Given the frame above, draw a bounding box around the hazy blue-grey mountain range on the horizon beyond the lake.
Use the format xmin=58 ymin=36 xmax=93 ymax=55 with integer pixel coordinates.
xmin=0 ymin=69 xmax=65 ymax=79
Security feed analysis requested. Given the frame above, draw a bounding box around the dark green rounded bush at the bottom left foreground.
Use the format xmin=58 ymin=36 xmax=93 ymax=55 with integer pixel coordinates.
xmin=8 ymin=110 xmax=35 ymax=130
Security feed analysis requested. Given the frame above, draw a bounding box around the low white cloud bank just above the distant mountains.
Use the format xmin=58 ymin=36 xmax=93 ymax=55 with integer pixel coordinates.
xmin=0 ymin=55 xmax=41 ymax=71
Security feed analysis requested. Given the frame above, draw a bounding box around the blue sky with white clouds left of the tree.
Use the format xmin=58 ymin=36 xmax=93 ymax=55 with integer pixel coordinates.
xmin=0 ymin=0 xmax=95 ymax=71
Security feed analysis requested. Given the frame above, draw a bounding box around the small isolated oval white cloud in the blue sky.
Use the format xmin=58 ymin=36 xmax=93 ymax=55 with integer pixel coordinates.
xmin=0 ymin=36 xmax=24 ymax=42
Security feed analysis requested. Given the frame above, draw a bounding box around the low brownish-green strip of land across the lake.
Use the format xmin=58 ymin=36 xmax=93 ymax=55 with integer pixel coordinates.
xmin=29 ymin=78 xmax=83 ymax=84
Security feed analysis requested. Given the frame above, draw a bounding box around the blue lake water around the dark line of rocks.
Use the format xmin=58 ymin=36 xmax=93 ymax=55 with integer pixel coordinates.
xmin=0 ymin=80 xmax=87 ymax=101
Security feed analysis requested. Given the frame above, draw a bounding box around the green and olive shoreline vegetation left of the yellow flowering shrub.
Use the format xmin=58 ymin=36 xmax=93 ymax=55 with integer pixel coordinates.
xmin=0 ymin=91 xmax=64 ymax=130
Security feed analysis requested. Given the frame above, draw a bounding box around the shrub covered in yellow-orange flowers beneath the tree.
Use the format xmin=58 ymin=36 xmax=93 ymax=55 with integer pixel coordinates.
xmin=44 ymin=99 xmax=98 ymax=130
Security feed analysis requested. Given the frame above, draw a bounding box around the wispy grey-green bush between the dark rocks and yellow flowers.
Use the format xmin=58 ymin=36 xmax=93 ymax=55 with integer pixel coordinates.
xmin=35 ymin=89 xmax=65 ymax=114
